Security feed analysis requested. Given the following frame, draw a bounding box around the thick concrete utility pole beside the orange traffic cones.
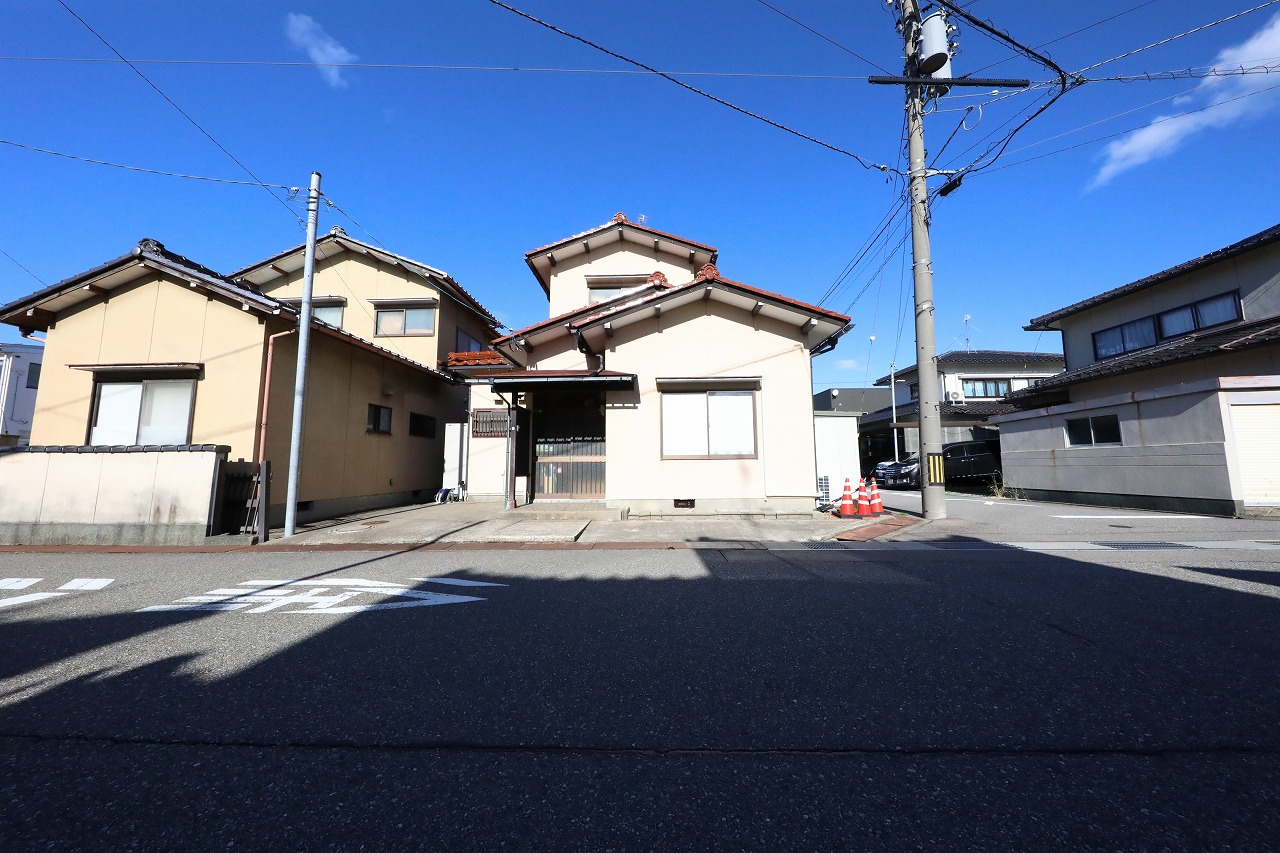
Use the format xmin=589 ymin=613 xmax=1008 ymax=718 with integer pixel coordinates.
xmin=899 ymin=0 xmax=947 ymax=519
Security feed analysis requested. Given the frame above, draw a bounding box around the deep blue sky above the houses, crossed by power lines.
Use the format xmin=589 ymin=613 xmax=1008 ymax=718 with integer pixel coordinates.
xmin=0 ymin=0 xmax=1280 ymax=389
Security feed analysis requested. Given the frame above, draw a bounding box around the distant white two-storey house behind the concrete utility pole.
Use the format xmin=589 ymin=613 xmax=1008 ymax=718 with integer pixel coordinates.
xmin=858 ymin=350 xmax=1064 ymax=470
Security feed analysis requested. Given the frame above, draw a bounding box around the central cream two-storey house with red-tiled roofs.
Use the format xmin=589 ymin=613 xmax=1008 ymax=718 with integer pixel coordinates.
xmin=449 ymin=214 xmax=849 ymax=514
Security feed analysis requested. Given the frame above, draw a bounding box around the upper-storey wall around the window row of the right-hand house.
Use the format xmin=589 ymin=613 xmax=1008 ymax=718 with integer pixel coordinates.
xmin=1059 ymin=243 xmax=1280 ymax=370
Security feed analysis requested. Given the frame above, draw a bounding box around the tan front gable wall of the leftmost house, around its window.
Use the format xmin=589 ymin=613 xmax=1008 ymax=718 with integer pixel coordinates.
xmin=31 ymin=274 xmax=264 ymax=459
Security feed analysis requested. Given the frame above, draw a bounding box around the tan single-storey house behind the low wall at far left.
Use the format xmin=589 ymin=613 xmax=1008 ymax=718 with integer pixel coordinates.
xmin=0 ymin=238 xmax=486 ymax=535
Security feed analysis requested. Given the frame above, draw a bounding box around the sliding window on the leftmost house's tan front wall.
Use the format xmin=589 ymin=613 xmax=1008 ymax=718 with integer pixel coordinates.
xmin=88 ymin=379 xmax=196 ymax=444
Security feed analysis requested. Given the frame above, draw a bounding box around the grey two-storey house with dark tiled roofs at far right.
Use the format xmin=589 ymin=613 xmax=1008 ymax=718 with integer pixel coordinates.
xmin=997 ymin=225 xmax=1280 ymax=515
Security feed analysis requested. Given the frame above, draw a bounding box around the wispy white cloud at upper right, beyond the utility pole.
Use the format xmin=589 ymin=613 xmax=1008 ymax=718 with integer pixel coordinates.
xmin=1089 ymin=14 xmax=1280 ymax=190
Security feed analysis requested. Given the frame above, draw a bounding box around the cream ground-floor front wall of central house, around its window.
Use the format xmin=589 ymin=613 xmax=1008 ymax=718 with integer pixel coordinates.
xmin=605 ymin=301 xmax=817 ymax=512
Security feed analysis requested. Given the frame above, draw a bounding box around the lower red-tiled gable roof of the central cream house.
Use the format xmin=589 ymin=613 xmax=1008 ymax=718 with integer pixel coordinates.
xmin=493 ymin=264 xmax=849 ymax=360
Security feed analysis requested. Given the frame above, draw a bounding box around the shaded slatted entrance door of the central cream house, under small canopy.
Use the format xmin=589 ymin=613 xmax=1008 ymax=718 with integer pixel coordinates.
xmin=532 ymin=392 xmax=604 ymax=500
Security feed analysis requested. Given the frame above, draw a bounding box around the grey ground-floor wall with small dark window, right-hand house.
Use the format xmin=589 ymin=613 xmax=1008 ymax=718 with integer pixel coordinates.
xmin=992 ymin=380 xmax=1242 ymax=515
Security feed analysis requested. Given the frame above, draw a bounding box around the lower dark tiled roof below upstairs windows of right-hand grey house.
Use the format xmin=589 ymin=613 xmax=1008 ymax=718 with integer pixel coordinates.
xmin=1005 ymin=316 xmax=1280 ymax=403
